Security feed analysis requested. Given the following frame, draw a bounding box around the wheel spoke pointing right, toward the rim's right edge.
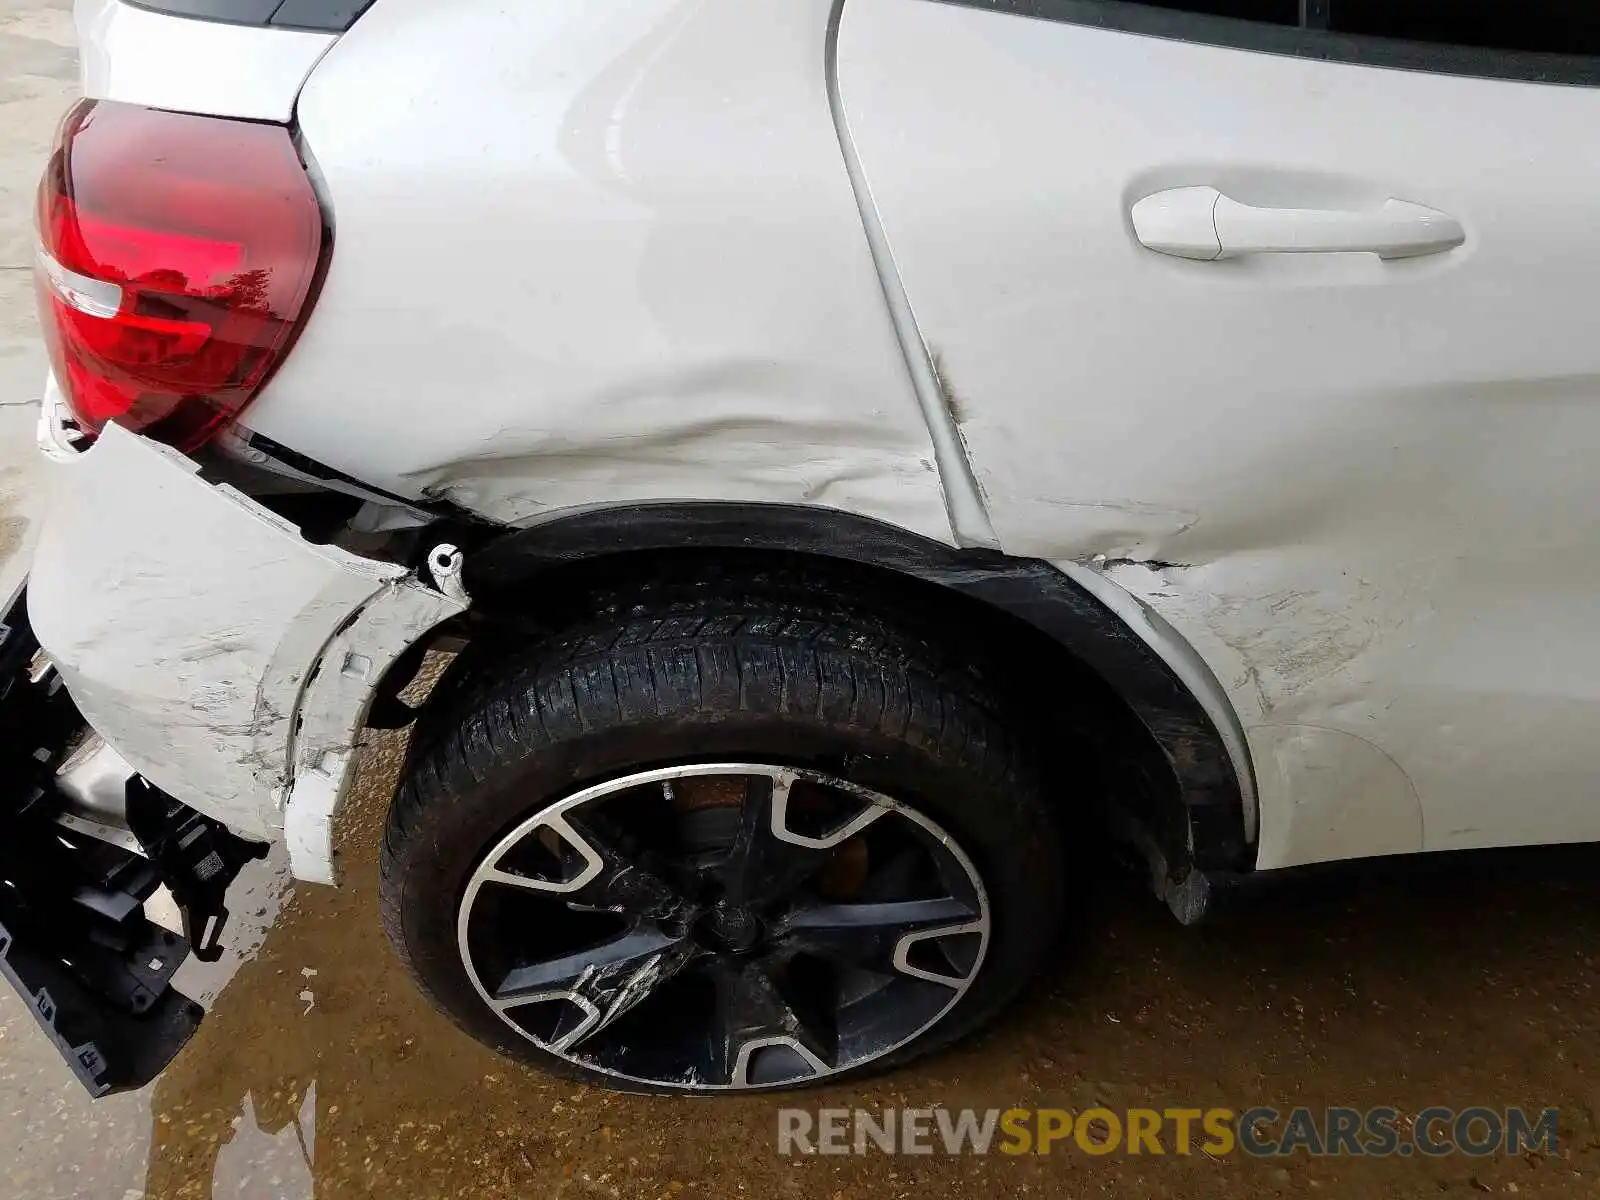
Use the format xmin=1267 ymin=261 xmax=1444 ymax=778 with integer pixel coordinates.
xmin=779 ymin=898 xmax=982 ymax=987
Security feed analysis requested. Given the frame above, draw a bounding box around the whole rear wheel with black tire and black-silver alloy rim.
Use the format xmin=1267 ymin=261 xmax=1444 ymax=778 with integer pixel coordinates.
xmin=382 ymin=589 xmax=1061 ymax=1091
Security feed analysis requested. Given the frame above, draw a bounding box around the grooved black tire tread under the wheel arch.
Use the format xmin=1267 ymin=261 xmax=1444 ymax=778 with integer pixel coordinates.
xmin=381 ymin=579 xmax=1059 ymax=1088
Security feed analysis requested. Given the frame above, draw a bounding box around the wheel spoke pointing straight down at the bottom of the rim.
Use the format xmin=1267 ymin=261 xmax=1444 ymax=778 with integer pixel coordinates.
xmin=709 ymin=957 xmax=838 ymax=1088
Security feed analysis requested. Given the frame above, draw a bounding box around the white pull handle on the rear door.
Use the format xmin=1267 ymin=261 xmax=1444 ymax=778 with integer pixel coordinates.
xmin=1133 ymin=187 xmax=1467 ymax=262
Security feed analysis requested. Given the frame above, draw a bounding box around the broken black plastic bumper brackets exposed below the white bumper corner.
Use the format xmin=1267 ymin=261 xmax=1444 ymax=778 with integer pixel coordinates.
xmin=0 ymin=592 xmax=264 ymax=1096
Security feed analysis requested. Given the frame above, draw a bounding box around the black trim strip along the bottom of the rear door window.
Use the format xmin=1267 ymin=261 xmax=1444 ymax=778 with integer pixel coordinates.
xmin=931 ymin=0 xmax=1600 ymax=86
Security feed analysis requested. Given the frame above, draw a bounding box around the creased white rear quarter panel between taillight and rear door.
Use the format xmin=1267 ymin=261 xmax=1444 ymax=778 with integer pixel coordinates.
xmin=246 ymin=0 xmax=952 ymax=542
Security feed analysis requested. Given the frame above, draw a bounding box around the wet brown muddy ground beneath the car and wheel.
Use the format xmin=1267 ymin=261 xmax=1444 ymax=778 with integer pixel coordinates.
xmin=124 ymin=739 xmax=1600 ymax=1200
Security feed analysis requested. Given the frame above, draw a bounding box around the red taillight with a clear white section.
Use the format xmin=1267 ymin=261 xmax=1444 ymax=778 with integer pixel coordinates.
xmin=35 ymin=101 xmax=326 ymax=450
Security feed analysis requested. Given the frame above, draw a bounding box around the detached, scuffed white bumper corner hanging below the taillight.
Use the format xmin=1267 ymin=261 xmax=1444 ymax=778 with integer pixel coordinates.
xmin=29 ymin=426 xmax=466 ymax=883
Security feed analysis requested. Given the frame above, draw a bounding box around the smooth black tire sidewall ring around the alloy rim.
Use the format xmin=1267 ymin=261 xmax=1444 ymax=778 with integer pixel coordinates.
xmin=382 ymin=712 xmax=1062 ymax=1094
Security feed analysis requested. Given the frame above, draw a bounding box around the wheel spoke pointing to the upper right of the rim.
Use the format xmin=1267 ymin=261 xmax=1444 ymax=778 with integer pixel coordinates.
xmin=717 ymin=771 xmax=890 ymax=907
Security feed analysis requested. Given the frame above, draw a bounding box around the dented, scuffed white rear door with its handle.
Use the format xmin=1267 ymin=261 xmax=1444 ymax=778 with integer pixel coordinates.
xmin=837 ymin=0 xmax=1600 ymax=867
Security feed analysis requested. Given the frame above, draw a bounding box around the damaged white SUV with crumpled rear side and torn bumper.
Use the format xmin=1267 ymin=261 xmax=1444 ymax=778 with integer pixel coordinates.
xmin=0 ymin=0 xmax=1600 ymax=1091
